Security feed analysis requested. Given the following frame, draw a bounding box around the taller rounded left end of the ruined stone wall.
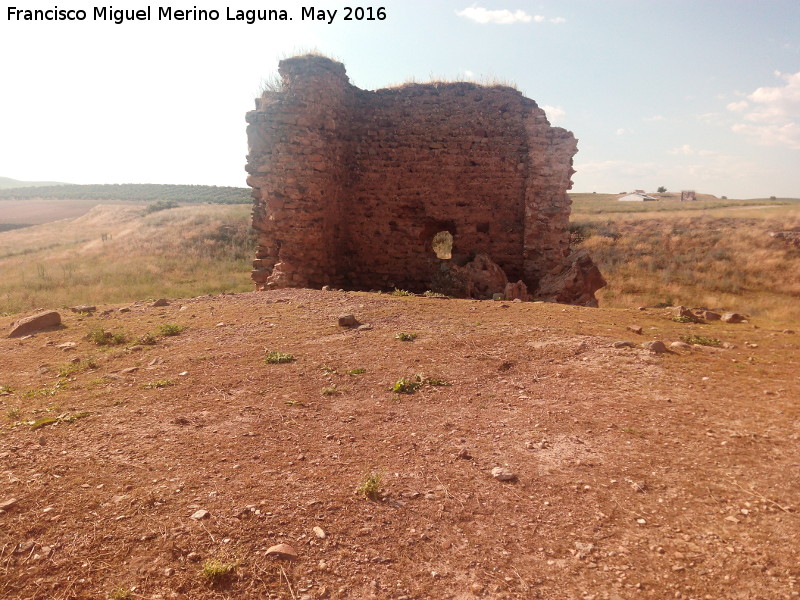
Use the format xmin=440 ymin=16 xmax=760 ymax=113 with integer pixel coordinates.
xmin=247 ymin=61 xmax=353 ymax=287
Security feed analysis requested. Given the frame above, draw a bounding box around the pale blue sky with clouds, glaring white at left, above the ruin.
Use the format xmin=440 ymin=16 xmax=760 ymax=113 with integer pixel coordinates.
xmin=0 ymin=0 xmax=800 ymax=198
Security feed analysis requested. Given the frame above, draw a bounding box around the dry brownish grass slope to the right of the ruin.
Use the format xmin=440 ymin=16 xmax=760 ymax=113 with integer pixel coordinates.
xmin=572 ymin=209 xmax=800 ymax=321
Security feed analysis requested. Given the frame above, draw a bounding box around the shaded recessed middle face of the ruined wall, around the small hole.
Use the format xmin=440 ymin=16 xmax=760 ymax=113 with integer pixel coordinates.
xmin=342 ymin=84 xmax=528 ymax=290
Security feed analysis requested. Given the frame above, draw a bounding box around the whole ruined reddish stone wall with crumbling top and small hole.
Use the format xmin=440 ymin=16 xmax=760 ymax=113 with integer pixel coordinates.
xmin=247 ymin=56 xmax=602 ymax=304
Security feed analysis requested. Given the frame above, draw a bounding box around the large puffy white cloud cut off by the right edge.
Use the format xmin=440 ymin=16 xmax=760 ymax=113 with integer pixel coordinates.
xmin=728 ymin=71 xmax=800 ymax=150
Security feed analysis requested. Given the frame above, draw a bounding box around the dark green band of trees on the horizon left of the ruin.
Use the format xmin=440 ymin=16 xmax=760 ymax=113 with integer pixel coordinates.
xmin=0 ymin=183 xmax=252 ymax=204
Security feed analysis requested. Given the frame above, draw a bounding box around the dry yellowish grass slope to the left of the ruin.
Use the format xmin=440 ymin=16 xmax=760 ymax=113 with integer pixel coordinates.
xmin=0 ymin=205 xmax=254 ymax=314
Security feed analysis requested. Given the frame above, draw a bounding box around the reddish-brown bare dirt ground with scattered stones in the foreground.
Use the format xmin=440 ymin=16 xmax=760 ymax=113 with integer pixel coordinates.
xmin=0 ymin=290 xmax=800 ymax=600
